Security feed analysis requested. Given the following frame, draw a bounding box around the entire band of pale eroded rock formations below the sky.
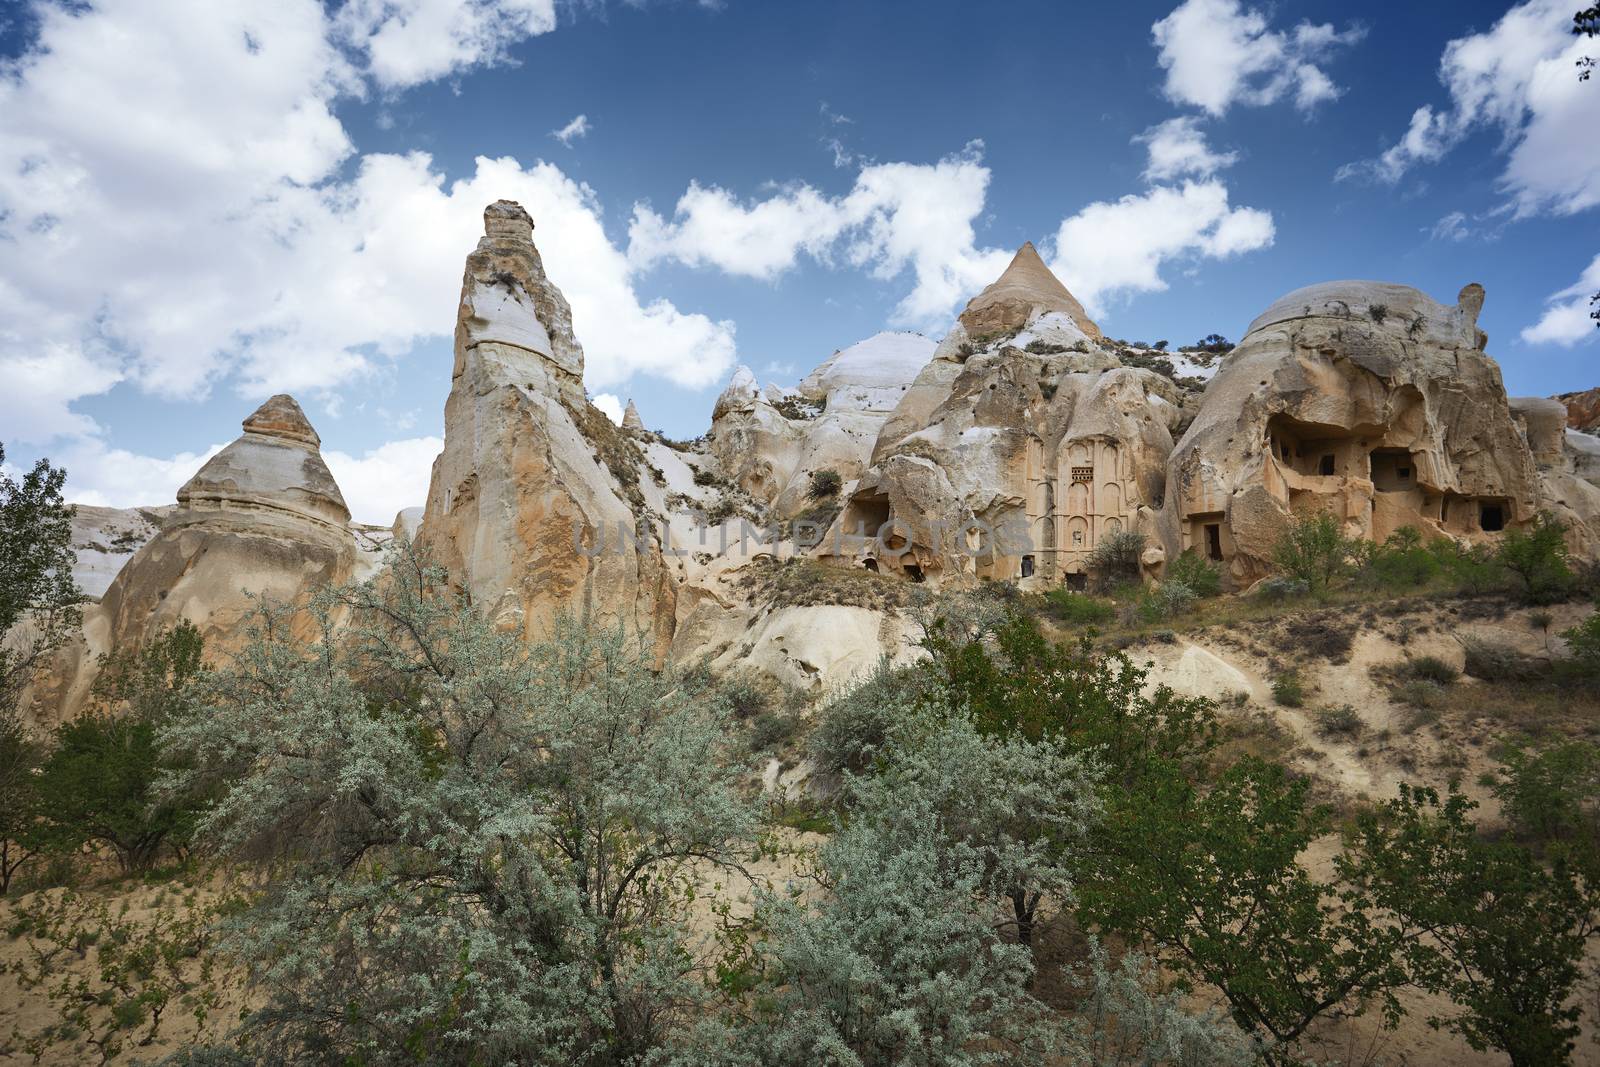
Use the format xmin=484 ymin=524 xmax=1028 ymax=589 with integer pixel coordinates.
xmin=38 ymin=200 xmax=1600 ymax=703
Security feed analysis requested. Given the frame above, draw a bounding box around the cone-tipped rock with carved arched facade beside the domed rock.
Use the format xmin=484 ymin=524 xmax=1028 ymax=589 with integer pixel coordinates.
xmin=818 ymin=245 xmax=1179 ymax=581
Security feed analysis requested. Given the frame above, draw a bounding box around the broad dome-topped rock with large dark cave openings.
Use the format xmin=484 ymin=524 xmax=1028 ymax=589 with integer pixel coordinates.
xmin=1162 ymin=282 xmax=1552 ymax=584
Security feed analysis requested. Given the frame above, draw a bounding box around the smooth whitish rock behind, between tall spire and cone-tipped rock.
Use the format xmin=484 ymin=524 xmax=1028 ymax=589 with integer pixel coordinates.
xmin=709 ymin=333 xmax=934 ymax=518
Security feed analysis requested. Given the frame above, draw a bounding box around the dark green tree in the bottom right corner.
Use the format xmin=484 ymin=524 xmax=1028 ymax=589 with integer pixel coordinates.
xmin=1352 ymin=789 xmax=1600 ymax=1067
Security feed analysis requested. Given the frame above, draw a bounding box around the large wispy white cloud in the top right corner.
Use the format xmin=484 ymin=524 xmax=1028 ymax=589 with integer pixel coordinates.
xmin=1338 ymin=0 xmax=1600 ymax=216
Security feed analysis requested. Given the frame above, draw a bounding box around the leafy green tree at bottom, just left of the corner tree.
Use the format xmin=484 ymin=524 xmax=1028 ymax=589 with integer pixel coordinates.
xmin=1078 ymin=758 xmax=1416 ymax=1064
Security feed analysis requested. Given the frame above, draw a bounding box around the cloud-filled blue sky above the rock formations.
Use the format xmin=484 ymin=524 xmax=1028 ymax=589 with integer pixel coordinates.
xmin=0 ymin=0 xmax=1600 ymax=522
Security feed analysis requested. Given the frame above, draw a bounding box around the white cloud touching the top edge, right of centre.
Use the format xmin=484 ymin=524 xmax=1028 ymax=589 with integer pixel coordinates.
xmin=1150 ymin=0 xmax=1366 ymax=115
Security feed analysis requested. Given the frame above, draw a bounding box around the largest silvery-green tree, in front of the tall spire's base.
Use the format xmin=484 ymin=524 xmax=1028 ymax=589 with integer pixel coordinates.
xmin=163 ymin=544 xmax=754 ymax=1065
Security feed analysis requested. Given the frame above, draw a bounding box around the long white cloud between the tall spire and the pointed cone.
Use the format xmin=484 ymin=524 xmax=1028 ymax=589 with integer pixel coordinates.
xmin=629 ymin=142 xmax=1006 ymax=325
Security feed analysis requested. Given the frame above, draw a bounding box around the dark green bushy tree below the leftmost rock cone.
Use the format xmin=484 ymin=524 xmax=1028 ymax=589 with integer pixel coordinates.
xmin=38 ymin=622 xmax=203 ymax=872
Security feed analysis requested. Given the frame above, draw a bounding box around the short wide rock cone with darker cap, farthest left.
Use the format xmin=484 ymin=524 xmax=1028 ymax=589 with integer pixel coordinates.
xmin=37 ymin=395 xmax=363 ymax=720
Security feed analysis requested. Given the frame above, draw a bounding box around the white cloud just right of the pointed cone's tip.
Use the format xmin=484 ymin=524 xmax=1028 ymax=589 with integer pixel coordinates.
xmin=1050 ymin=179 xmax=1274 ymax=314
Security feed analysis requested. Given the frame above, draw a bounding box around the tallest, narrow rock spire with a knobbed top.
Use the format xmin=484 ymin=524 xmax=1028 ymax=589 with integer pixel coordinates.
xmin=418 ymin=200 xmax=674 ymax=651
